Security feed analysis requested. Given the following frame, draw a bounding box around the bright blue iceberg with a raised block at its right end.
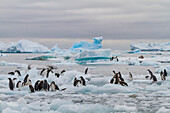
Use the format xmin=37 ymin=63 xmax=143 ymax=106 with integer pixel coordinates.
xmin=70 ymin=37 xmax=103 ymax=52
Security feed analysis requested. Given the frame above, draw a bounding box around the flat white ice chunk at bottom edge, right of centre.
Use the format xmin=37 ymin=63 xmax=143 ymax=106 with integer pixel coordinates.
xmin=114 ymin=105 xmax=137 ymax=113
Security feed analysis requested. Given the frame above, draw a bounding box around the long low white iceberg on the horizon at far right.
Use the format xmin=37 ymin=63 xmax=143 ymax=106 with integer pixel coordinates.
xmin=130 ymin=42 xmax=170 ymax=51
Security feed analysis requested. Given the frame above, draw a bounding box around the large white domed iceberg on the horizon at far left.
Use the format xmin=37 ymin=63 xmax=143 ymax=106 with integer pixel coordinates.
xmin=0 ymin=39 xmax=51 ymax=53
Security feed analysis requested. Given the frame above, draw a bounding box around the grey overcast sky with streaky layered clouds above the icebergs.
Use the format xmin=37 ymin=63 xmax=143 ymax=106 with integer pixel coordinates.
xmin=0 ymin=0 xmax=170 ymax=39
